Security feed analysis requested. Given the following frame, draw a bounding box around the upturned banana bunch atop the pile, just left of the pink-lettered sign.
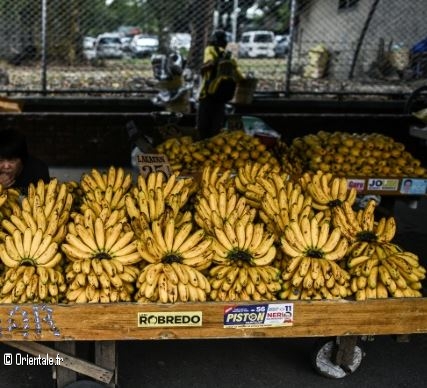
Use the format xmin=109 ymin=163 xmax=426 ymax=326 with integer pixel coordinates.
xmin=300 ymin=170 xmax=357 ymax=212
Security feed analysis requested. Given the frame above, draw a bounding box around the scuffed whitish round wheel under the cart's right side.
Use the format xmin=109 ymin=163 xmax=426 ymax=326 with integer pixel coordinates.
xmin=313 ymin=337 xmax=364 ymax=379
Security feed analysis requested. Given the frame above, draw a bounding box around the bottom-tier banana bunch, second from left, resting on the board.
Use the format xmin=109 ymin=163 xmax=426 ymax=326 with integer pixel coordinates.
xmin=65 ymin=256 xmax=139 ymax=303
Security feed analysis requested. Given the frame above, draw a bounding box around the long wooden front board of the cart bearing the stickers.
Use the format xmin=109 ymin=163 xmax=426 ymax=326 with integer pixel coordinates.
xmin=0 ymin=298 xmax=427 ymax=341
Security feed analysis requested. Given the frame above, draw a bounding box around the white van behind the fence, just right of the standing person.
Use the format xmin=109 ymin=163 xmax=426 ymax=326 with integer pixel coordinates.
xmin=239 ymin=31 xmax=276 ymax=58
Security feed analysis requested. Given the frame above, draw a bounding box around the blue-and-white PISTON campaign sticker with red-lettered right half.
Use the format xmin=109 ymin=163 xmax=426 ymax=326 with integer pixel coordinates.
xmin=224 ymin=303 xmax=294 ymax=329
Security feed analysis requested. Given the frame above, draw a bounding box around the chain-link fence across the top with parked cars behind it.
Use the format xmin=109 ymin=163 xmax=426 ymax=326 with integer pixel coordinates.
xmin=0 ymin=0 xmax=427 ymax=96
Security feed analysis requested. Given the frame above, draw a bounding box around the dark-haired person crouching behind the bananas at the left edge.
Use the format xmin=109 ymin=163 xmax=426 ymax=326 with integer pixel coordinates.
xmin=0 ymin=129 xmax=50 ymax=194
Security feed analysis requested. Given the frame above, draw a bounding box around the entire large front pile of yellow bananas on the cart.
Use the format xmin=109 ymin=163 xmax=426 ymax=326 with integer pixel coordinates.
xmin=0 ymin=161 xmax=426 ymax=303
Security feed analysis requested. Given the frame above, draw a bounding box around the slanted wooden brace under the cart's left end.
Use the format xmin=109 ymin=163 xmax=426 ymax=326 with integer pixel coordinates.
xmin=2 ymin=341 xmax=113 ymax=383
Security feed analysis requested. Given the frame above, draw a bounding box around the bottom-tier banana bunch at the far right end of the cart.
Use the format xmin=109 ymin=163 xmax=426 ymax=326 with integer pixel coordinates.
xmin=347 ymin=242 xmax=426 ymax=300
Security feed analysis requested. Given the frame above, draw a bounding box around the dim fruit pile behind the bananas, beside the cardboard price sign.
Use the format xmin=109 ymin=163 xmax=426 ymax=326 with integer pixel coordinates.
xmin=156 ymin=131 xmax=280 ymax=172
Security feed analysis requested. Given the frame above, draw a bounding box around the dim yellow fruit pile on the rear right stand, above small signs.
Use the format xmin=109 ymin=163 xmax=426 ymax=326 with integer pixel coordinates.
xmin=286 ymin=131 xmax=427 ymax=177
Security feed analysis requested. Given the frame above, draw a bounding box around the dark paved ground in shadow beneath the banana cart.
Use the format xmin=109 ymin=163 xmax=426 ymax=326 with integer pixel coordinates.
xmin=0 ymin=334 xmax=427 ymax=388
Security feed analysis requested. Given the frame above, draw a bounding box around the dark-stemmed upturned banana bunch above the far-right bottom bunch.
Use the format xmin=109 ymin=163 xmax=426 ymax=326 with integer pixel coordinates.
xmin=332 ymin=200 xmax=396 ymax=244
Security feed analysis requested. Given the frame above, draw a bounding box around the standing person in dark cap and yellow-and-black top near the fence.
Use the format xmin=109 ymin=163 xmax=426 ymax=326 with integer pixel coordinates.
xmin=196 ymin=30 xmax=244 ymax=139
